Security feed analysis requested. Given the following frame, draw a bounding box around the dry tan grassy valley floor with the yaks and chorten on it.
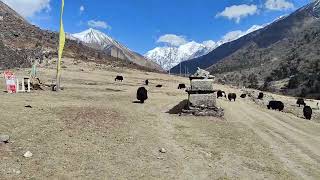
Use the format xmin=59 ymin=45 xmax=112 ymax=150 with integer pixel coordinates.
xmin=0 ymin=60 xmax=320 ymax=179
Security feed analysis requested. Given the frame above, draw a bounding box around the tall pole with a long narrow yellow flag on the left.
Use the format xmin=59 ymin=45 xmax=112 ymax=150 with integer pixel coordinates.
xmin=56 ymin=0 xmax=66 ymax=91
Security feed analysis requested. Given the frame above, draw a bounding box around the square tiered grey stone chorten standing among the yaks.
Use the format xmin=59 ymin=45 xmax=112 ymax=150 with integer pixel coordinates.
xmin=182 ymin=68 xmax=224 ymax=117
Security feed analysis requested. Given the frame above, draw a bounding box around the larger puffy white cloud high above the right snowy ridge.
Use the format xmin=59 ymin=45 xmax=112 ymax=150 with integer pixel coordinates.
xmin=216 ymin=4 xmax=258 ymax=23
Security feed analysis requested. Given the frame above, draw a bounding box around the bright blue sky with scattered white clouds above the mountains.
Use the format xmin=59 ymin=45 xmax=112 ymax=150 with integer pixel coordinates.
xmin=2 ymin=0 xmax=310 ymax=54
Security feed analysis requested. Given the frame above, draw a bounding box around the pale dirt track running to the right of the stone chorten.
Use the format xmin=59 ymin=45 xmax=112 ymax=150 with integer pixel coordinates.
xmin=221 ymin=100 xmax=320 ymax=179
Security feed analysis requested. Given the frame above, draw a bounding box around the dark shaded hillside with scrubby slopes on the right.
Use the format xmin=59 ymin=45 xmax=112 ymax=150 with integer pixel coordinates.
xmin=172 ymin=1 xmax=320 ymax=98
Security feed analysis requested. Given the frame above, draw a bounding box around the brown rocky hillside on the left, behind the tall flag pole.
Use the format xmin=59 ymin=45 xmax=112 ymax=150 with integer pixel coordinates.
xmin=0 ymin=1 xmax=158 ymax=71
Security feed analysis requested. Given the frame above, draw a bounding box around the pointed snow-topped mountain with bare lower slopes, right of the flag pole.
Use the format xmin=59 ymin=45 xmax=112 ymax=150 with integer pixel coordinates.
xmin=69 ymin=28 xmax=162 ymax=70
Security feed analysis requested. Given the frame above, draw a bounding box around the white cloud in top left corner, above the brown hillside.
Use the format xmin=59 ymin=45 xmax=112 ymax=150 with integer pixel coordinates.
xmin=2 ymin=0 xmax=51 ymax=17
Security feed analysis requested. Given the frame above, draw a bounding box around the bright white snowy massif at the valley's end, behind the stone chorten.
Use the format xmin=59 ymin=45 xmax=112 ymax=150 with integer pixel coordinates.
xmin=145 ymin=41 xmax=217 ymax=70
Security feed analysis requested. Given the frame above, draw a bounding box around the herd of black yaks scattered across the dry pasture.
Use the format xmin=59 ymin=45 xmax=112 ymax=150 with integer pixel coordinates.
xmin=115 ymin=76 xmax=312 ymax=120
